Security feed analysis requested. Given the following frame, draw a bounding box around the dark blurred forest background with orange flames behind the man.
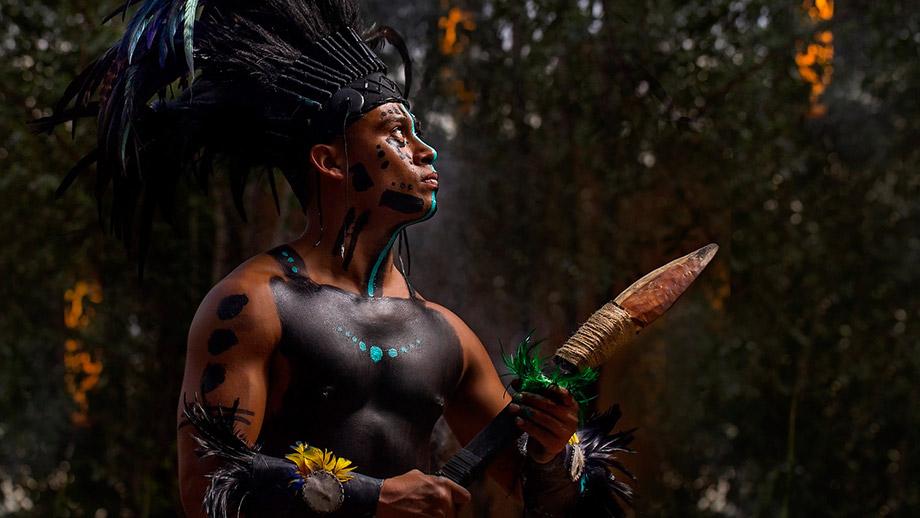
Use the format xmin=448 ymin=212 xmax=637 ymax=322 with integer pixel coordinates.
xmin=0 ymin=0 xmax=920 ymax=518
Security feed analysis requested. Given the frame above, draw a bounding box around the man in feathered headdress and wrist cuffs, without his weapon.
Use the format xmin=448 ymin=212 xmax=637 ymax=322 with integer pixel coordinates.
xmin=39 ymin=0 xmax=606 ymax=517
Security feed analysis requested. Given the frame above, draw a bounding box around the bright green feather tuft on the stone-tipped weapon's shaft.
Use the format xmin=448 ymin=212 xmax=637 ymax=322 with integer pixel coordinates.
xmin=502 ymin=332 xmax=597 ymax=420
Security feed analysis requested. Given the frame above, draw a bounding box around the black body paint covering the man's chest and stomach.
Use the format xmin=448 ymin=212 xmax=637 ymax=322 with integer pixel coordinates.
xmin=259 ymin=247 xmax=463 ymax=478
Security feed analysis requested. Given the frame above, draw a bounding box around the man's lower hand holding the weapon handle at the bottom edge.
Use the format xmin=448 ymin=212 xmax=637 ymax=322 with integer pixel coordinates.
xmin=376 ymin=469 xmax=470 ymax=518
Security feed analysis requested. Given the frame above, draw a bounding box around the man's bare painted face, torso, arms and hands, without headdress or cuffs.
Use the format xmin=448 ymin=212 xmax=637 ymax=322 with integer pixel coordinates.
xmin=179 ymin=99 xmax=578 ymax=517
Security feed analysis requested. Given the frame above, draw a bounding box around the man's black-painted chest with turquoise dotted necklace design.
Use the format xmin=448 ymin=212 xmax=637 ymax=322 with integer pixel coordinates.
xmin=270 ymin=248 xmax=463 ymax=456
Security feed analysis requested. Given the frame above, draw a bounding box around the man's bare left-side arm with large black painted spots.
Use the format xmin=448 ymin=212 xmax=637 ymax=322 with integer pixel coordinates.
xmin=178 ymin=273 xmax=281 ymax=516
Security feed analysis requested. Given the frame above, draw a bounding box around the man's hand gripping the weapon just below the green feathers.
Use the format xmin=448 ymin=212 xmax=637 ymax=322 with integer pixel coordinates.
xmin=511 ymin=387 xmax=578 ymax=464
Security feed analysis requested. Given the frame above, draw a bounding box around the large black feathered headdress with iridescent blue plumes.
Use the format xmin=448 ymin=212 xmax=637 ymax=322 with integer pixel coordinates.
xmin=34 ymin=0 xmax=412 ymax=271
